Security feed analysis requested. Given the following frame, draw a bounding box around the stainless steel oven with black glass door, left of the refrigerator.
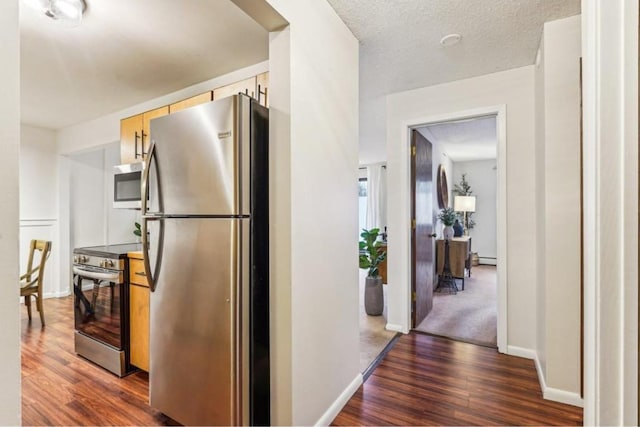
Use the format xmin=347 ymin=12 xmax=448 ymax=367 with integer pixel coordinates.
xmin=73 ymin=245 xmax=135 ymax=377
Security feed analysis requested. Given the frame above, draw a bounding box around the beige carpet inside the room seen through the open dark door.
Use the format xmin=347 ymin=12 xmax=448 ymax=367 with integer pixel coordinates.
xmin=416 ymin=265 xmax=497 ymax=347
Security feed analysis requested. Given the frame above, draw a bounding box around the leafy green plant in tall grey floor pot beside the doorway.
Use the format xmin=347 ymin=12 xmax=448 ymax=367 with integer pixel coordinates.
xmin=360 ymin=228 xmax=387 ymax=316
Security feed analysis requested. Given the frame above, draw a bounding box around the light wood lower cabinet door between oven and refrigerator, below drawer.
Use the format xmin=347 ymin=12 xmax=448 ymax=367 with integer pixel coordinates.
xmin=129 ymin=284 xmax=149 ymax=372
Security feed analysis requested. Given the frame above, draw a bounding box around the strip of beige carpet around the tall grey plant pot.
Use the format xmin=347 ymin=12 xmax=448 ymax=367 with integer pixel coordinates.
xmin=360 ymin=270 xmax=396 ymax=372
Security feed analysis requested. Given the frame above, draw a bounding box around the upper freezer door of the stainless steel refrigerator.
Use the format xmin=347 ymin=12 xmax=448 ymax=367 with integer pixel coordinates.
xmin=148 ymin=95 xmax=251 ymax=216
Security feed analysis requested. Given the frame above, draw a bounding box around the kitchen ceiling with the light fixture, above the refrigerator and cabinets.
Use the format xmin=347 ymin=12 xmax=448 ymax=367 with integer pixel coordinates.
xmin=20 ymin=0 xmax=269 ymax=129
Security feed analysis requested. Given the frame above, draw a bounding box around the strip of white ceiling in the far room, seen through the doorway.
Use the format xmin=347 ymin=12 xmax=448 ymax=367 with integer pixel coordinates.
xmin=418 ymin=116 xmax=498 ymax=162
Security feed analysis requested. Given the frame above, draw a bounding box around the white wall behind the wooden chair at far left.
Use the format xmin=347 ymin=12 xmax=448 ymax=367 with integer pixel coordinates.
xmin=20 ymin=125 xmax=61 ymax=298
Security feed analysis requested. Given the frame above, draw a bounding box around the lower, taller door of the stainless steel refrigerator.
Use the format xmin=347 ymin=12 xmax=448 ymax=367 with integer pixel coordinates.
xmin=149 ymin=218 xmax=250 ymax=425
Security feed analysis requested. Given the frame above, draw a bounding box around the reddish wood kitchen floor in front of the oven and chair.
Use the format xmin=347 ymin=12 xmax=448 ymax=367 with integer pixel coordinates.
xmin=21 ymin=297 xmax=171 ymax=425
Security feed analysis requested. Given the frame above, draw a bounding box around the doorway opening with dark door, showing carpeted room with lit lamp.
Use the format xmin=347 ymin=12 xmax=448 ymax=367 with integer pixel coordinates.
xmin=411 ymin=114 xmax=498 ymax=347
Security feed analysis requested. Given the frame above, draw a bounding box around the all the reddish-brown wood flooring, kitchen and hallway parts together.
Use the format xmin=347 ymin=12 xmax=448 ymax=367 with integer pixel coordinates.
xmin=22 ymin=297 xmax=582 ymax=425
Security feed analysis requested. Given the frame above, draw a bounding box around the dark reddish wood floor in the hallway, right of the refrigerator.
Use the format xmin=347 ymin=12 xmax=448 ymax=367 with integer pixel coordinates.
xmin=333 ymin=333 xmax=582 ymax=426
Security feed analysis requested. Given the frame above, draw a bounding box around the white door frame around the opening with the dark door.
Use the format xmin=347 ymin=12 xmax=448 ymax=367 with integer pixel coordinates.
xmin=402 ymin=104 xmax=508 ymax=353
